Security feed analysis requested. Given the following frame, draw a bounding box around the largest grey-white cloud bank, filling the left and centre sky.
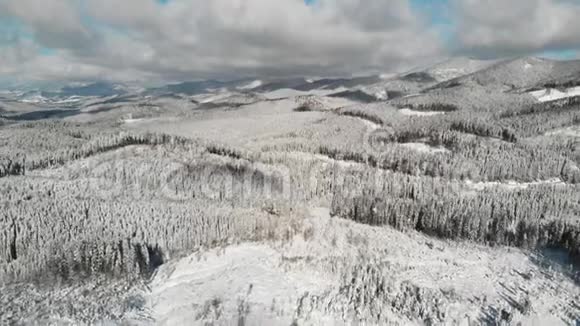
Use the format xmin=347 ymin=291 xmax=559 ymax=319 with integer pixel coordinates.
xmin=0 ymin=0 xmax=441 ymax=79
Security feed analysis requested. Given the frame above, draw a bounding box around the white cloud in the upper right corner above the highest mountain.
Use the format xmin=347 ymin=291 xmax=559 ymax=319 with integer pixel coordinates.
xmin=454 ymin=0 xmax=580 ymax=56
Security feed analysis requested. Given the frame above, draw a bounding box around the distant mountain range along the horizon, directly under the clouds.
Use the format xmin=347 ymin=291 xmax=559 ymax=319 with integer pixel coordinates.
xmin=6 ymin=57 xmax=580 ymax=103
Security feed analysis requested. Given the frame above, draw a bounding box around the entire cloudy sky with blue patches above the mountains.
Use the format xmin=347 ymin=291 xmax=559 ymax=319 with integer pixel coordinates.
xmin=0 ymin=0 xmax=580 ymax=81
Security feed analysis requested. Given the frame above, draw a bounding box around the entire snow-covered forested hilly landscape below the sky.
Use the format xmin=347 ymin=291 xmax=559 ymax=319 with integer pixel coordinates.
xmin=0 ymin=58 xmax=580 ymax=325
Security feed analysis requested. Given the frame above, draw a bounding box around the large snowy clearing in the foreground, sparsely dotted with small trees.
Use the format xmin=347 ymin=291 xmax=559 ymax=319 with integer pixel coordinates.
xmin=146 ymin=208 xmax=580 ymax=325
